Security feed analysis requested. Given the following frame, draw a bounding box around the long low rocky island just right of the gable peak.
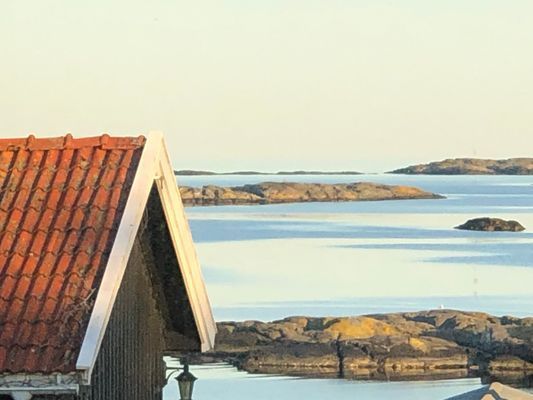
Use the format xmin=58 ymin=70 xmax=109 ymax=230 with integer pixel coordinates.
xmin=180 ymin=182 xmax=444 ymax=206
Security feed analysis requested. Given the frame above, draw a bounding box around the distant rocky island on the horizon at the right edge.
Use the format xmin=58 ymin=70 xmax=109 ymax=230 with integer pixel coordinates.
xmin=390 ymin=158 xmax=533 ymax=175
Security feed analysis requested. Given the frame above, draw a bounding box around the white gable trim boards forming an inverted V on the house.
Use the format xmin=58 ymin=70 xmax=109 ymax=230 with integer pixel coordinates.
xmin=76 ymin=132 xmax=216 ymax=384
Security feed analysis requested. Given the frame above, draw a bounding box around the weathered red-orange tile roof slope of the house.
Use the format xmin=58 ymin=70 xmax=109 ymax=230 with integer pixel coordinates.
xmin=0 ymin=135 xmax=145 ymax=373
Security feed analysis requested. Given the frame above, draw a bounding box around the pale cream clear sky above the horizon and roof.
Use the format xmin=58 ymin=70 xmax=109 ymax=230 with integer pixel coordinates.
xmin=0 ymin=0 xmax=533 ymax=171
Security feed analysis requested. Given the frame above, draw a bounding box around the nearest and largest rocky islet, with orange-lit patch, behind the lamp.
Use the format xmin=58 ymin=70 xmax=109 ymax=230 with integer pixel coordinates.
xmin=204 ymin=310 xmax=533 ymax=381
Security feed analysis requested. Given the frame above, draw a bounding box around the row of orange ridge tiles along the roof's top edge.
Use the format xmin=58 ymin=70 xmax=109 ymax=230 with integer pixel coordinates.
xmin=0 ymin=133 xmax=146 ymax=151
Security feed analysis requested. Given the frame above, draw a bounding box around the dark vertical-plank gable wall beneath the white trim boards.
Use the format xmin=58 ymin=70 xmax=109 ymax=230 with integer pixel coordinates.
xmin=81 ymin=238 xmax=165 ymax=400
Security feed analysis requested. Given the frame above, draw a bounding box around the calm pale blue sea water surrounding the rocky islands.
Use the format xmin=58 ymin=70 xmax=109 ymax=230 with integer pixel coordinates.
xmin=165 ymin=174 xmax=533 ymax=400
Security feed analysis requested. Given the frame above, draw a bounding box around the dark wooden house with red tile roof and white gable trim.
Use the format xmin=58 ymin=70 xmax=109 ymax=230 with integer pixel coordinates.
xmin=0 ymin=133 xmax=216 ymax=400
